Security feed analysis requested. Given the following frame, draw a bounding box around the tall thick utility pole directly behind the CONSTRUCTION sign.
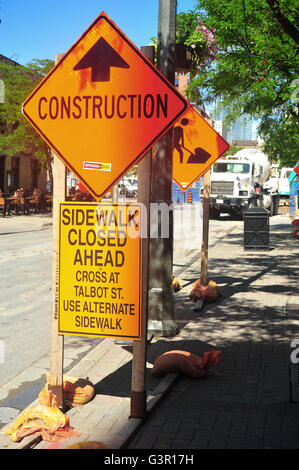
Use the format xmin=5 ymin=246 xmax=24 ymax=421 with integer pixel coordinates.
xmin=148 ymin=0 xmax=177 ymax=336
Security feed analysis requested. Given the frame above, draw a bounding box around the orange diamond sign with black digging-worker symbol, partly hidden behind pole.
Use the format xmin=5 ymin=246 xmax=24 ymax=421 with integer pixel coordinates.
xmin=173 ymin=108 xmax=229 ymax=191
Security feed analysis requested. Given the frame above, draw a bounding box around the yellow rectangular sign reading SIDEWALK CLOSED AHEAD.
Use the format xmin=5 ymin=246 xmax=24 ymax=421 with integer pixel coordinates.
xmin=58 ymin=202 xmax=142 ymax=340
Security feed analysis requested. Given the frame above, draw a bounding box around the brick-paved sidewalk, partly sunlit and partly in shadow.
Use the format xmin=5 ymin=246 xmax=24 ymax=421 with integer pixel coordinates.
xmin=0 ymin=216 xmax=299 ymax=449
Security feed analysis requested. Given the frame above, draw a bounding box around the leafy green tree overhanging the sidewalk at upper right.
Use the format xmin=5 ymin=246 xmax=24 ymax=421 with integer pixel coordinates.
xmin=187 ymin=0 xmax=299 ymax=166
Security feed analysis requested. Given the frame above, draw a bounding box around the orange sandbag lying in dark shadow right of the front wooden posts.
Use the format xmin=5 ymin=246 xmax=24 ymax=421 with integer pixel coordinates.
xmin=152 ymin=349 xmax=221 ymax=379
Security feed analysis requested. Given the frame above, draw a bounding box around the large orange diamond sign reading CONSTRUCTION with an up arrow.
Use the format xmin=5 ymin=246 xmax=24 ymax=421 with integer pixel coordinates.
xmin=23 ymin=13 xmax=190 ymax=200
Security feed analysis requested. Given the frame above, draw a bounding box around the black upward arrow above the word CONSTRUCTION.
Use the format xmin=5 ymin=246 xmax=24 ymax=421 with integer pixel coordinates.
xmin=74 ymin=38 xmax=130 ymax=82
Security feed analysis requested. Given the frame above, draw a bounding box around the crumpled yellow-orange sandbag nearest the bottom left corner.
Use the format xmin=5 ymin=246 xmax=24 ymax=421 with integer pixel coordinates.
xmin=4 ymin=405 xmax=78 ymax=442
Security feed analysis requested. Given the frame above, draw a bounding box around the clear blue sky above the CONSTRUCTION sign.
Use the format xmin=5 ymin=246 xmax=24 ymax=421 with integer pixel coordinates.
xmin=0 ymin=0 xmax=196 ymax=65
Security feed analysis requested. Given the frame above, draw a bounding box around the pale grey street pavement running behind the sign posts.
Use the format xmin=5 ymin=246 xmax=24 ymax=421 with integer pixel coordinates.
xmin=0 ymin=204 xmax=292 ymax=427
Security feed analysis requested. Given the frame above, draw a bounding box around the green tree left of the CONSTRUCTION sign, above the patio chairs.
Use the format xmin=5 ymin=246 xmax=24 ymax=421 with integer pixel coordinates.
xmin=0 ymin=59 xmax=54 ymax=190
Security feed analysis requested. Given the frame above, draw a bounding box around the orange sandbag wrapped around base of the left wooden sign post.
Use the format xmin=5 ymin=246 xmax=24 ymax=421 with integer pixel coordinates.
xmin=38 ymin=374 xmax=95 ymax=406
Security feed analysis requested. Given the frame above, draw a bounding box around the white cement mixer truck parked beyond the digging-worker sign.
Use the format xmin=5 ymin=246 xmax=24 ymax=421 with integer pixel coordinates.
xmin=206 ymin=149 xmax=279 ymax=219
